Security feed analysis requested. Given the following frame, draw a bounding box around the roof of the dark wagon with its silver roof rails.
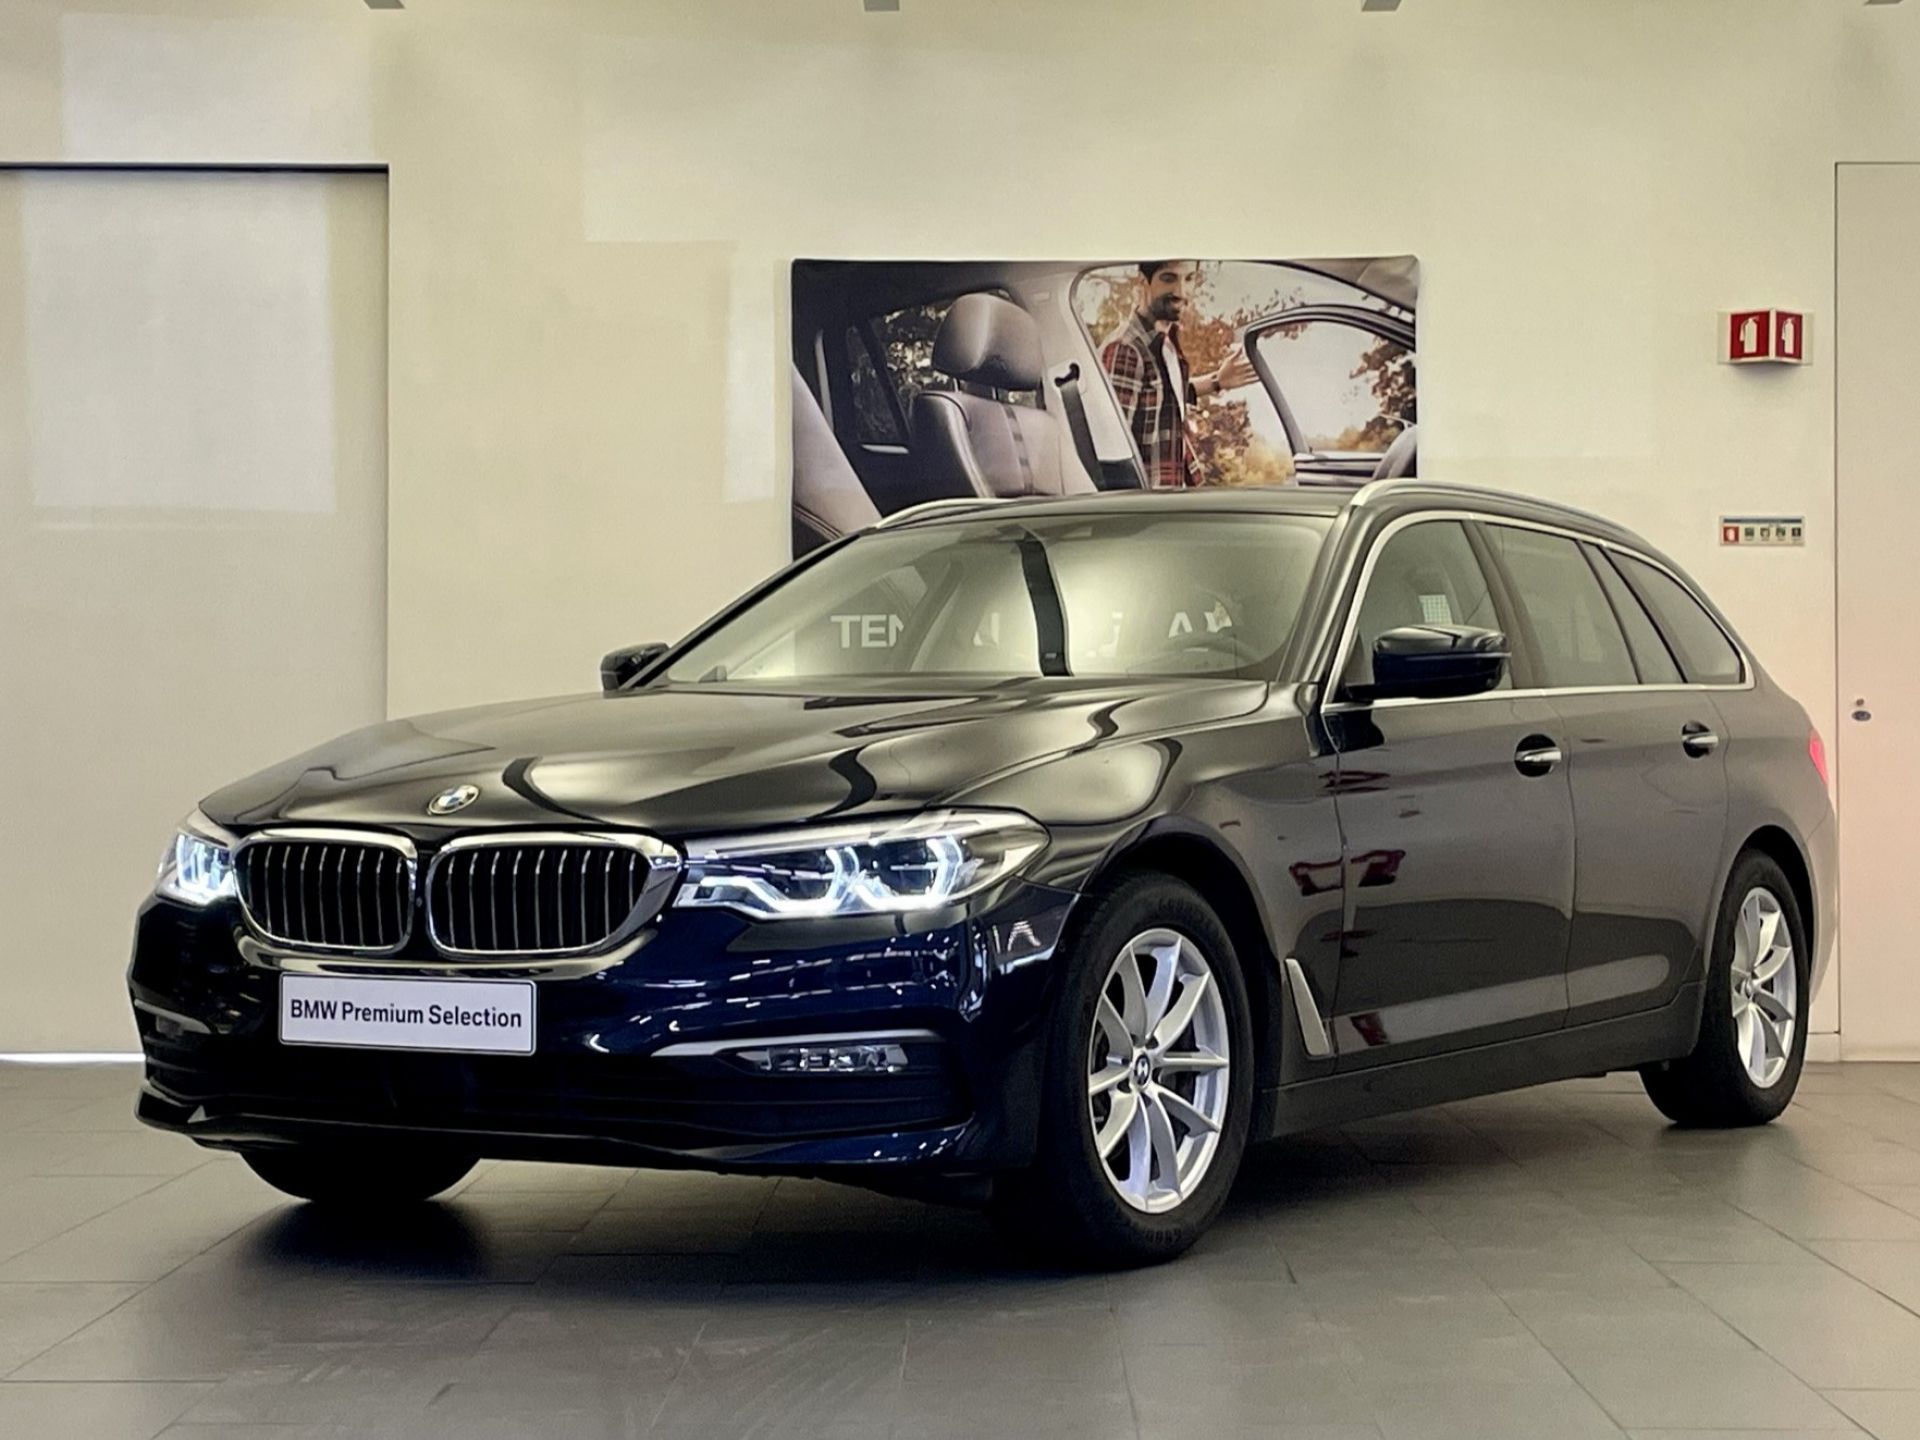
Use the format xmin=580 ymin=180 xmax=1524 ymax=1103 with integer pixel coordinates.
xmin=877 ymin=478 xmax=1651 ymax=549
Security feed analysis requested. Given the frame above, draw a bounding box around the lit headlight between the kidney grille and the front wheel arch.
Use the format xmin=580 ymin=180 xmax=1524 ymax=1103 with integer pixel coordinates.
xmin=674 ymin=810 xmax=1046 ymax=920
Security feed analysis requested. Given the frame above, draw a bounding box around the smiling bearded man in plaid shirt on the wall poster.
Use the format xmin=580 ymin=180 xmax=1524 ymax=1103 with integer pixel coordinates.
xmin=1100 ymin=259 xmax=1258 ymax=490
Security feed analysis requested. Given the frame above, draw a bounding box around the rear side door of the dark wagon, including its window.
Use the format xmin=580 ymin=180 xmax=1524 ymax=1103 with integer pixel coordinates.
xmin=1484 ymin=524 xmax=1738 ymax=1025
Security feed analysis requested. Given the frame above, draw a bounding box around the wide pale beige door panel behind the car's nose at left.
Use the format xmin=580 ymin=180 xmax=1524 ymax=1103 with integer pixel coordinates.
xmin=0 ymin=169 xmax=386 ymax=1052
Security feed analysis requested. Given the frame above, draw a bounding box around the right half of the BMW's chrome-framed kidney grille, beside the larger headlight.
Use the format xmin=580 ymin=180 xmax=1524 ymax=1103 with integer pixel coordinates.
xmin=426 ymin=831 xmax=680 ymax=956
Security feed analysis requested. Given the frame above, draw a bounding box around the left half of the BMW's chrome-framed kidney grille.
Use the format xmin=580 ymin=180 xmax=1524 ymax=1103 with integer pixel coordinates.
xmin=234 ymin=829 xmax=415 ymax=954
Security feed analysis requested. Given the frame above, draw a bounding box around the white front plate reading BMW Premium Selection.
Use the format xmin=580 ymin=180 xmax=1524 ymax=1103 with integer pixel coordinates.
xmin=280 ymin=975 xmax=534 ymax=1054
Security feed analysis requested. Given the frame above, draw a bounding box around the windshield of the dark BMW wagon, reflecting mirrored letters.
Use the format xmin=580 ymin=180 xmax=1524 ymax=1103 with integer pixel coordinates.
xmin=666 ymin=513 xmax=1332 ymax=685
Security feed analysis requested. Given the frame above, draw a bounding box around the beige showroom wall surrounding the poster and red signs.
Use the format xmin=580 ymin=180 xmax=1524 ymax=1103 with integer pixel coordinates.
xmin=0 ymin=0 xmax=1920 ymax=1044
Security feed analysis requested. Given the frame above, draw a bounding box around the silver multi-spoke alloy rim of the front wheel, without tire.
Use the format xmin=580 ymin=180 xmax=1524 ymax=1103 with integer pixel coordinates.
xmin=1087 ymin=929 xmax=1231 ymax=1213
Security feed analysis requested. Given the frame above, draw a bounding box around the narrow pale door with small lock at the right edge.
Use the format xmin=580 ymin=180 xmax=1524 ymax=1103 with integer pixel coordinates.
xmin=1834 ymin=165 xmax=1920 ymax=1060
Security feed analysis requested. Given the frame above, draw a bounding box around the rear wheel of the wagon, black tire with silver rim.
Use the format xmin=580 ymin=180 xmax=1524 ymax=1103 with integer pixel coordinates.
xmin=1640 ymin=851 xmax=1812 ymax=1127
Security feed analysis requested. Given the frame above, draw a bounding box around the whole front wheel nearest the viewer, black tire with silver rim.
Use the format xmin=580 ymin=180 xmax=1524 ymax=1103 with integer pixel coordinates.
xmin=993 ymin=874 xmax=1254 ymax=1269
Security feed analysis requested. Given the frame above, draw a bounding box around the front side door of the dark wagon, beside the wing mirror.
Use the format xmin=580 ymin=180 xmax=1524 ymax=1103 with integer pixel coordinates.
xmin=1323 ymin=516 xmax=1574 ymax=1069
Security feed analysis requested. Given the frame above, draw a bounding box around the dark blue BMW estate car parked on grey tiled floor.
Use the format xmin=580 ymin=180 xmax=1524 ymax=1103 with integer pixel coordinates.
xmin=129 ymin=480 xmax=1834 ymax=1263
